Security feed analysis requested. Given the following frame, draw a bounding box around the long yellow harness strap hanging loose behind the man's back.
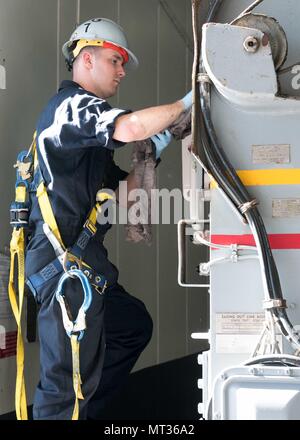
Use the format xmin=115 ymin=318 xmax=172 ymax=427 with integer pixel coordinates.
xmin=8 ymin=228 xmax=28 ymax=420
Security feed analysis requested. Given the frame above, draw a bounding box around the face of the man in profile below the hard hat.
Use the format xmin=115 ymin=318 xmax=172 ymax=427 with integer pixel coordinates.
xmin=91 ymin=48 xmax=126 ymax=99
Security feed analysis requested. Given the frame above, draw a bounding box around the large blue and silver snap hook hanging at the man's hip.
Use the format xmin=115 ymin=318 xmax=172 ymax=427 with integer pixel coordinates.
xmin=55 ymin=269 xmax=92 ymax=341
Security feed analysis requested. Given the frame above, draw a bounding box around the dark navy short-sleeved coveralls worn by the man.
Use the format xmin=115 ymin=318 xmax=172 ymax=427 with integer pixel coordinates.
xmin=26 ymin=81 xmax=152 ymax=420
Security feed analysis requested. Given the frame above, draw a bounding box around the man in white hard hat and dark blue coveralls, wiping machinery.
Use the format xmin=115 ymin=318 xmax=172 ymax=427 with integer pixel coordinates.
xmin=26 ymin=19 xmax=191 ymax=419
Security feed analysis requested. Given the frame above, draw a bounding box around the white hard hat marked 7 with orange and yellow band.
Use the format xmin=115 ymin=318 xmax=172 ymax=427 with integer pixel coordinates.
xmin=62 ymin=18 xmax=139 ymax=69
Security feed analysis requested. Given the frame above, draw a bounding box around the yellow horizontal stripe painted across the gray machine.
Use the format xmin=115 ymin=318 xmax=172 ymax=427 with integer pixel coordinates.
xmin=211 ymin=168 xmax=300 ymax=188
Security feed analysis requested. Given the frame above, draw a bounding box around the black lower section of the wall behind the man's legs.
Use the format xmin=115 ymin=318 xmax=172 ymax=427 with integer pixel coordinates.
xmin=98 ymin=354 xmax=202 ymax=420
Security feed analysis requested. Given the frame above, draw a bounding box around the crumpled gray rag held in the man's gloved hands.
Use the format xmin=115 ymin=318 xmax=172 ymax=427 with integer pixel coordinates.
xmin=125 ymin=110 xmax=191 ymax=245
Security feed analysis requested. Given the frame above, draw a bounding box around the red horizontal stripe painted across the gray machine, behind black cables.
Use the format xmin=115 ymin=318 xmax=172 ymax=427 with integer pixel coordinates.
xmin=211 ymin=234 xmax=300 ymax=249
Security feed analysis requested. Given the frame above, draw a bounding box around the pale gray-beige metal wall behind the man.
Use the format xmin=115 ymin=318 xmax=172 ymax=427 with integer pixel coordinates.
xmin=0 ymin=0 xmax=207 ymax=368
